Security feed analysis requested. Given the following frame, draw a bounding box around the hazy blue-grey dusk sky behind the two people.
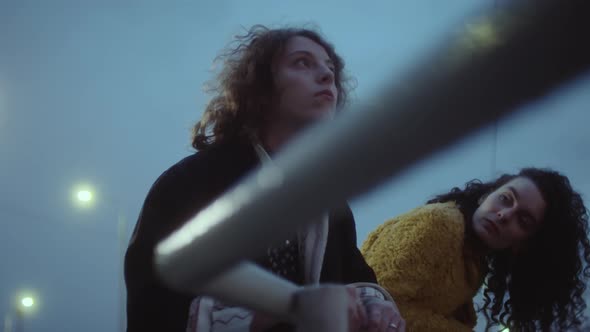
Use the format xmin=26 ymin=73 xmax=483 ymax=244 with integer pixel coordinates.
xmin=0 ymin=0 xmax=590 ymax=332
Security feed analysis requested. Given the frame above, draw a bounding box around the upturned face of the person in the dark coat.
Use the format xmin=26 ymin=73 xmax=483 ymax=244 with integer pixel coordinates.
xmin=270 ymin=36 xmax=338 ymax=126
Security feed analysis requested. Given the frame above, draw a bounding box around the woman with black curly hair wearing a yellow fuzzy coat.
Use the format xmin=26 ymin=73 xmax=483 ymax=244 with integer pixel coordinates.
xmin=361 ymin=168 xmax=590 ymax=331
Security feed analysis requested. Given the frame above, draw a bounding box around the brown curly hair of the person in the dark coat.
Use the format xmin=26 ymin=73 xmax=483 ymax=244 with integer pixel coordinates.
xmin=192 ymin=25 xmax=348 ymax=150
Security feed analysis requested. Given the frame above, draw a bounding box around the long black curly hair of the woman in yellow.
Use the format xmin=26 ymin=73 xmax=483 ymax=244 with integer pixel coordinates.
xmin=428 ymin=168 xmax=590 ymax=331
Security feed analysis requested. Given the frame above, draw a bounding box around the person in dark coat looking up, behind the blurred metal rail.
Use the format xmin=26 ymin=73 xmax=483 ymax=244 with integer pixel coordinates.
xmin=125 ymin=26 xmax=404 ymax=332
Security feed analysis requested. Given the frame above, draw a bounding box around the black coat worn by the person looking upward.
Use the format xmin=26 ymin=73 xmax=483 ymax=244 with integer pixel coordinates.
xmin=125 ymin=143 xmax=376 ymax=332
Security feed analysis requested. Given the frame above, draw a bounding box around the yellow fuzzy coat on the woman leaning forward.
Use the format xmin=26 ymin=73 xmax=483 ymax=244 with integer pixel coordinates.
xmin=361 ymin=202 xmax=484 ymax=332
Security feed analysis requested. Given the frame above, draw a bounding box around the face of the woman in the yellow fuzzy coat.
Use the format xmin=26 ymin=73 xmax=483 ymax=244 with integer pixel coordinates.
xmin=472 ymin=177 xmax=546 ymax=250
